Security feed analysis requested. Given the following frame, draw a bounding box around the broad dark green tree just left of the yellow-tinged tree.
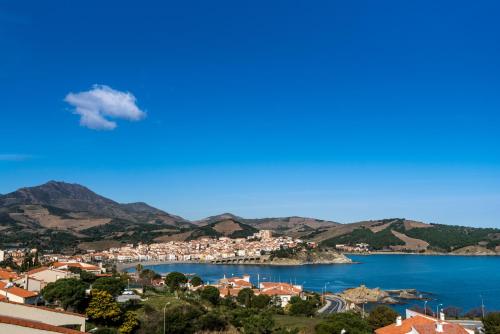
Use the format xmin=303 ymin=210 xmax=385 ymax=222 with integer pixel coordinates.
xmin=41 ymin=278 xmax=87 ymax=311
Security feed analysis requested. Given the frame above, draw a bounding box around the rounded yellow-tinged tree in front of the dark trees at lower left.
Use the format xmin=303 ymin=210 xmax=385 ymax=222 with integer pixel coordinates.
xmin=86 ymin=290 xmax=122 ymax=325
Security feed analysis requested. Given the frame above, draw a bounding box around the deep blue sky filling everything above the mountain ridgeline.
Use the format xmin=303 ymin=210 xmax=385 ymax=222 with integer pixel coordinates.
xmin=0 ymin=0 xmax=500 ymax=227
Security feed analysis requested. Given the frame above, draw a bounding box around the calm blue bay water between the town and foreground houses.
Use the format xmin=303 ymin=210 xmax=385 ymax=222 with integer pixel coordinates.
xmin=131 ymin=255 xmax=500 ymax=311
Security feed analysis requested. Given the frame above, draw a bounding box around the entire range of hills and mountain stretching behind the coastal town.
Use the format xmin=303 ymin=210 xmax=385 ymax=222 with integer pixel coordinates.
xmin=0 ymin=181 xmax=500 ymax=254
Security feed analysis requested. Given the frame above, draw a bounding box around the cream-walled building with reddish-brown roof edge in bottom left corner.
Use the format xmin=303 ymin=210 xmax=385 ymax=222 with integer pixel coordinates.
xmin=0 ymin=301 xmax=85 ymax=334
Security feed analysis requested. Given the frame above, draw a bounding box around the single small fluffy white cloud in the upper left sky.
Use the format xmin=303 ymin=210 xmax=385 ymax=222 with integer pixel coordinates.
xmin=64 ymin=85 xmax=146 ymax=130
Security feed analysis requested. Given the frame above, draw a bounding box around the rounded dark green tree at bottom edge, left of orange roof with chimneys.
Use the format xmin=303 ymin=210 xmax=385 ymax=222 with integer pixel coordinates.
xmin=315 ymin=312 xmax=372 ymax=334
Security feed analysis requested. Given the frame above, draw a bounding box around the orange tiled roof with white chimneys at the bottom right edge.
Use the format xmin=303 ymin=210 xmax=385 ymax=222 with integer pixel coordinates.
xmin=375 ymin=310 xmax=474 ymax=334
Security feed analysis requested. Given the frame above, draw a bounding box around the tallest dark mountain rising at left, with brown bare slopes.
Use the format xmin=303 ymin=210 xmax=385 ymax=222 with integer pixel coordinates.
xmin=0 ymin=181 xmax=193 ymax=249
